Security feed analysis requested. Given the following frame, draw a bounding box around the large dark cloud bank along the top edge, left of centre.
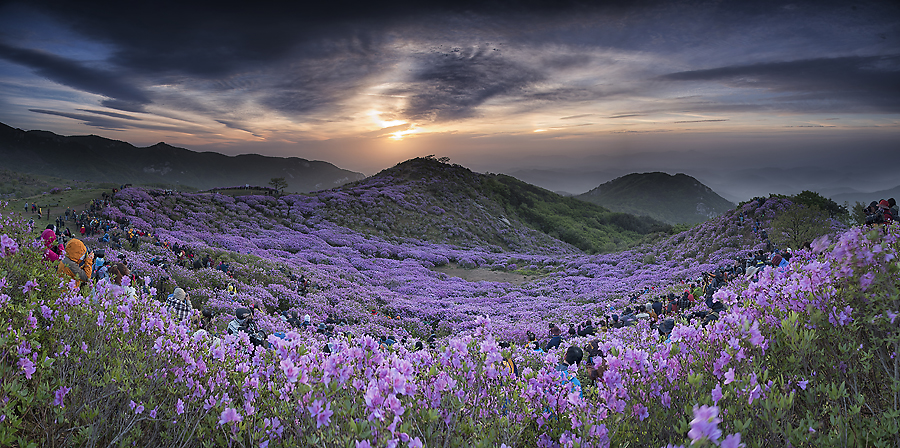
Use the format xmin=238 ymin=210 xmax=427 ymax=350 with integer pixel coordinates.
xmin=15 ymin=0 xmax=592 ymax=78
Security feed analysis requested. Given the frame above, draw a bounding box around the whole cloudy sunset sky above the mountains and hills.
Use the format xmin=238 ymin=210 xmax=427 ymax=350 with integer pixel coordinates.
xmin=0 ymin=0 xmax=900 ymax=200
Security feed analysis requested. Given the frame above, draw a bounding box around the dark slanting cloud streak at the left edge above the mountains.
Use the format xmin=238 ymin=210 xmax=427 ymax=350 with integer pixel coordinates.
xmin=0 ymin=42 xmax=150 ymax=111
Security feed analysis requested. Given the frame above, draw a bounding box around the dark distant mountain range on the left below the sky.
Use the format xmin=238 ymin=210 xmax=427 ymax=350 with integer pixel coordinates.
xmin=0 ymin=123 xmax=365 ymax=192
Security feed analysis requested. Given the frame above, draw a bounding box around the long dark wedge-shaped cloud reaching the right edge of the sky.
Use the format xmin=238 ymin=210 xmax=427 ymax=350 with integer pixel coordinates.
xmin=661 ymin=54 xmax=900 ymax=113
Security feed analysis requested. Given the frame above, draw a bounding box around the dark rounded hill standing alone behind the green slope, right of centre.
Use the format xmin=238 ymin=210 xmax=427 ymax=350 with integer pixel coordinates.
xmin=576 ymin=172 xmax=734 ymax=224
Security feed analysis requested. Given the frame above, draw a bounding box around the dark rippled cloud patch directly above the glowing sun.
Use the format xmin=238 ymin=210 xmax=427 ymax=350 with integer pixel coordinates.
xmin=395 ymin=47 xmax=544 ymax=122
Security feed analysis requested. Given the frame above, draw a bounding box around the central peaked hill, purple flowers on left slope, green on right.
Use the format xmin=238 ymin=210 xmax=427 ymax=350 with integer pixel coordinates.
xmin=318 ymin=157 xmax=671 ymax=253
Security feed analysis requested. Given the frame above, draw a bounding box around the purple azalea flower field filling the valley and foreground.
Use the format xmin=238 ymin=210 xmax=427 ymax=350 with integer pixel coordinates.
xmin=0 ymin=170 xmax=900 ymax=448
